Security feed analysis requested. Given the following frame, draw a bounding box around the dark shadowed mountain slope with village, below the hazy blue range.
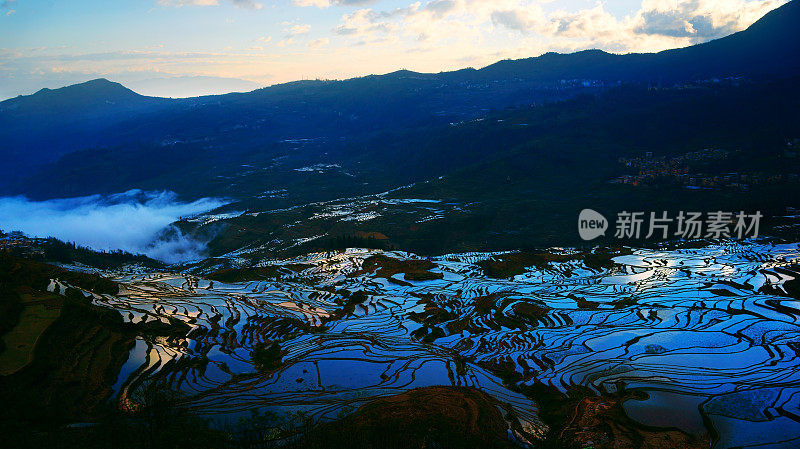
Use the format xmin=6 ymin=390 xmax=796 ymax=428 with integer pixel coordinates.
xmin=175 ymin=77 xmax=800 ymax=257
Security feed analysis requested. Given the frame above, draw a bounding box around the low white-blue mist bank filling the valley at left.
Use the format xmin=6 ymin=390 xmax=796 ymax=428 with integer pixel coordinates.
xmin=0 ymin=190 xmax=225 ymax=263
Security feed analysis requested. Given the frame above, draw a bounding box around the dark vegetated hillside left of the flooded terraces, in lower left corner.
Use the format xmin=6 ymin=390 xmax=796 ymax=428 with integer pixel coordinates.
xmin=0 ymin=254 xmax=189 ymax=429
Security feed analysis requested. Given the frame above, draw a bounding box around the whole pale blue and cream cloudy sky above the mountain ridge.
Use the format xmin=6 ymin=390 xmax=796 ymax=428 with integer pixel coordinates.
xmin=0 ymin=0 xmax=786 ymax=100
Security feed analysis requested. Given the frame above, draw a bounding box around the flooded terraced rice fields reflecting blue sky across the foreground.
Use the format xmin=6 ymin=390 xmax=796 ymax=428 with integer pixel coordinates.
xmin=65 ymin=243 xmax=800 ymax=448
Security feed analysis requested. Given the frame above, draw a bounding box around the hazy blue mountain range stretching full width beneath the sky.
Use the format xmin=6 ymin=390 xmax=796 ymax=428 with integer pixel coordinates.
xmin=0 ymin=0 xmax=800 ymax=201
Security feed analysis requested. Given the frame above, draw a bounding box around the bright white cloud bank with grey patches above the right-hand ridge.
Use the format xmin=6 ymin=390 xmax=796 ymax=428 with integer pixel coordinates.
xmin=334 ymin=0 xmax=786 ymax=57
